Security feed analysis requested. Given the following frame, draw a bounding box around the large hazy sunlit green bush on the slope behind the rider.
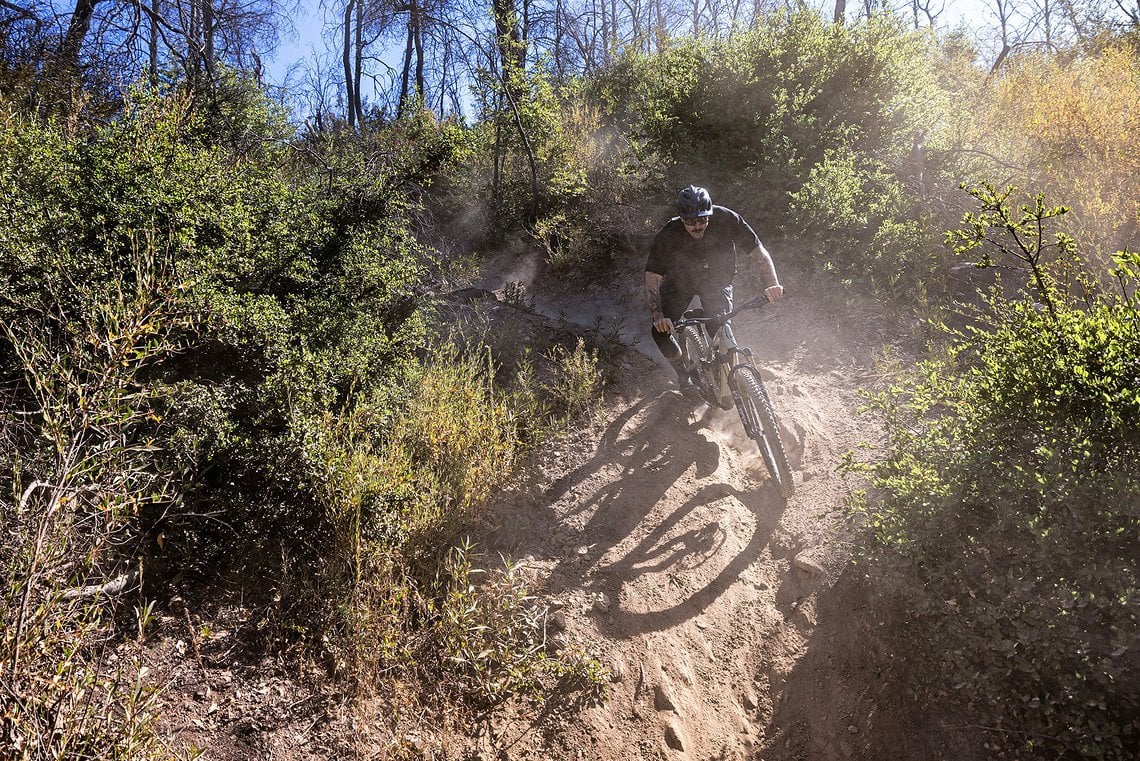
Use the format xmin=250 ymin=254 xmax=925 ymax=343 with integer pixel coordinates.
xmin=579 ymin=11 xmax=956 ymax=305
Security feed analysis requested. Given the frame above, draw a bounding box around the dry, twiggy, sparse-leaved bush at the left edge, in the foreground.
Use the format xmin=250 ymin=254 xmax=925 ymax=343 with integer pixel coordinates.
xmin=0 ymin=242 xmax=193 ymax=760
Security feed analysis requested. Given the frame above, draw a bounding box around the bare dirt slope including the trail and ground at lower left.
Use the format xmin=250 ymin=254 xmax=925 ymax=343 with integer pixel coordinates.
xmin=149 ymin=252 xmax=983 ymax=761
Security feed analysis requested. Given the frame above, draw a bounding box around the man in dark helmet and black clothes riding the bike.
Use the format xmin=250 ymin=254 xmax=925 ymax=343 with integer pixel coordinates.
xmin=645 ymin=185 xmax=783 ymax=396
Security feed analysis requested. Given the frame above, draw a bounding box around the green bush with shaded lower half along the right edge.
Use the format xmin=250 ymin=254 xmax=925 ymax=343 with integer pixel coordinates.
xmin=856 ymin=189 xmax=1140 ymax=759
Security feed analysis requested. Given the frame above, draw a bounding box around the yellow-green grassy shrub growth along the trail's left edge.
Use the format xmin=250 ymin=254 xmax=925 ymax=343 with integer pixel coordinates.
xmin=301 ymin=344 xmax=604 ymax=731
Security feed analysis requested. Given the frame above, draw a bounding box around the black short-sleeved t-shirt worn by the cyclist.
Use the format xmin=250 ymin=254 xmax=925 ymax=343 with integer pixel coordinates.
xmin=645 ymin=206 xmax=760 ymax=287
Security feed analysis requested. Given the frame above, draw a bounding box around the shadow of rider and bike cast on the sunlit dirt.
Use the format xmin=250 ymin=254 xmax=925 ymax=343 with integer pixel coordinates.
xmin=531 ymin=382 xmax=783 ymax=638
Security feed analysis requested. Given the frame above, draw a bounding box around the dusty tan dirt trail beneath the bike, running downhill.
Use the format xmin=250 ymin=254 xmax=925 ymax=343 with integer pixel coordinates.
xmin=469 ymin=257 xmax=942 ymax=761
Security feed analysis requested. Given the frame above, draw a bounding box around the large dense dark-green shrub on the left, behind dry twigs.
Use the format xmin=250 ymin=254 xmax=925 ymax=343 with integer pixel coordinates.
xmin=0 ymin=82 xmax=426 ymax=637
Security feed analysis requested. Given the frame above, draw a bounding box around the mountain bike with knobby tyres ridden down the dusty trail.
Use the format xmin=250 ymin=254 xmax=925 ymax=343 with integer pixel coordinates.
xmin=673 ymin=297 xmax=796 ymax=499
